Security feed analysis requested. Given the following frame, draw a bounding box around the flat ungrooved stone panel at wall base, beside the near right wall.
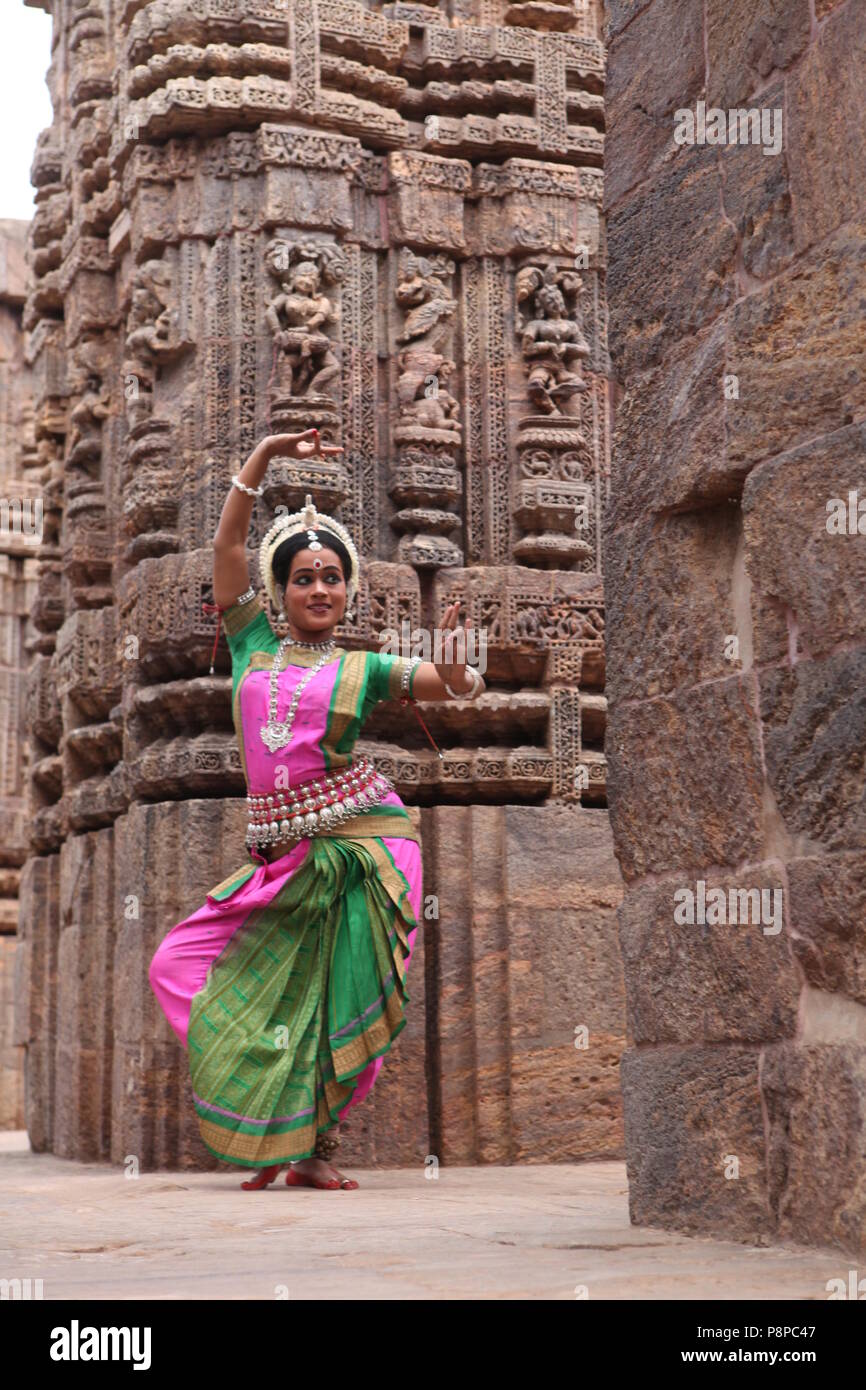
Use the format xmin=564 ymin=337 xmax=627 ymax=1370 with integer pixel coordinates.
xmin=503 ymin=808 xmax=624 ymax=1162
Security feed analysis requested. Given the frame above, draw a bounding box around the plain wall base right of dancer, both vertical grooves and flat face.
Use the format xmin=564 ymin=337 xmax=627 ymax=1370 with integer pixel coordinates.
xmin=424 ymin=806 xmax=624 ymax=1163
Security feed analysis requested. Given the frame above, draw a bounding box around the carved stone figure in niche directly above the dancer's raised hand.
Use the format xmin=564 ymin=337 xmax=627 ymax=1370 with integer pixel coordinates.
xmin=265 ymin=240 xmax=346 ymax=396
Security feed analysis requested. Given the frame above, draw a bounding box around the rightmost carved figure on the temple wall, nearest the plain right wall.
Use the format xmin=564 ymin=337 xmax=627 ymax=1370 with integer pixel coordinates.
xmin=516 ymin=261 xmax=589 ymax=416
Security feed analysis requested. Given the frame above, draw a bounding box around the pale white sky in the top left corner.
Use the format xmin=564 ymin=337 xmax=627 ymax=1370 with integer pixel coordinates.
xmin=0 ymin=0 xmax=53 ymax=220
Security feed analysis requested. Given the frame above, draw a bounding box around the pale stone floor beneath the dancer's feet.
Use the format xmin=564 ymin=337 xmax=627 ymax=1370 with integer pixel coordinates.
xmin=0 ymin=1133 xmax=851 ymax=1300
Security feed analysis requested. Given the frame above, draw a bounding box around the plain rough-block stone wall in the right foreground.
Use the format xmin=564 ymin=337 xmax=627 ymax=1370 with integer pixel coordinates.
xmin=605 ymin=0 xmax=866 ymax=1254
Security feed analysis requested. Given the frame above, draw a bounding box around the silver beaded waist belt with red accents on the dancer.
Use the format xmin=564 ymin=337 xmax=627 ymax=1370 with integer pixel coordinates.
xmin=246 ymin=758 xmax=393 ymax=849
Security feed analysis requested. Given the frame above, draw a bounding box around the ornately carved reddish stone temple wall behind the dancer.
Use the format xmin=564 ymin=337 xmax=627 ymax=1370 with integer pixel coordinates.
xmin=10 ymin=0 xmax=626 ymax=1166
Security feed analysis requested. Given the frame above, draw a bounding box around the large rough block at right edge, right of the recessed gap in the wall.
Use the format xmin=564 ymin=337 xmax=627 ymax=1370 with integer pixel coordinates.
xmin=742 ymin=424 xmax=866 ymax=664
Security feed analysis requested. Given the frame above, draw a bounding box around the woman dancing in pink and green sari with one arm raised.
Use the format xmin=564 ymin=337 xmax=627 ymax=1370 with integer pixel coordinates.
xmin=150 ymin=430 xmax=484 ymax=1190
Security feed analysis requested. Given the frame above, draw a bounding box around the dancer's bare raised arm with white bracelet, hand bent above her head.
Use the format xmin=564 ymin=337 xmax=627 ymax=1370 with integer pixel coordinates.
xmin=213 ymin=430 xmax=343 ymax=607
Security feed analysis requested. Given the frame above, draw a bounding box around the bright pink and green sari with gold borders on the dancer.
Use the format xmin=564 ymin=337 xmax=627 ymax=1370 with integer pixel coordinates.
xmin=150 ymin=599 xmax=421 ymax=1168
